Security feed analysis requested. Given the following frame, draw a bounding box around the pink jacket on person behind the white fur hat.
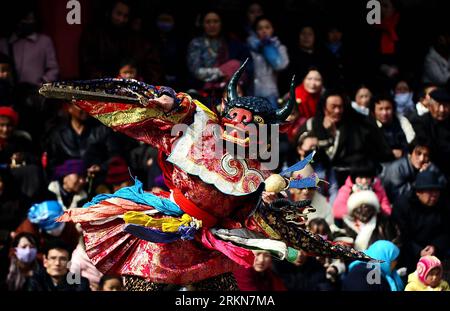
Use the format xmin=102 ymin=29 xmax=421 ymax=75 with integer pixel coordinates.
xmin=333 ymin=176 xmax=392 ymax=219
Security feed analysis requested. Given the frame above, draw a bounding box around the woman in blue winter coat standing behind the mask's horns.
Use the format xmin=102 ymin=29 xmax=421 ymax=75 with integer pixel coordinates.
xmin=247 ymin=16 xmax=289 ymax=108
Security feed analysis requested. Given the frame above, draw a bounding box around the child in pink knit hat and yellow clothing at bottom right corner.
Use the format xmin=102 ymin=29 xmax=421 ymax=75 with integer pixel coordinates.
xmin=405 ymin=255 xmax=450 ymax=291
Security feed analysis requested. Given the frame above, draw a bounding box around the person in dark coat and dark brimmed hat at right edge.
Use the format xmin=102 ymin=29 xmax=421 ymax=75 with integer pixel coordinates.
xmin=392 ymin=171 xmax=450 ymax=270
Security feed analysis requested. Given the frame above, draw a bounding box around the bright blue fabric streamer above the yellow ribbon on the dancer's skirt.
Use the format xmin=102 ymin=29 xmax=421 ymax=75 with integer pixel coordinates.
xmin=83 ymin=178 xmax=184 ymax=216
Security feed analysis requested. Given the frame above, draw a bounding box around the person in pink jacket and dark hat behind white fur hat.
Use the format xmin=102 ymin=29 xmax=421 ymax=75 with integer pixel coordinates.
xmin=333 ymin=163 xmax=392 ymax=219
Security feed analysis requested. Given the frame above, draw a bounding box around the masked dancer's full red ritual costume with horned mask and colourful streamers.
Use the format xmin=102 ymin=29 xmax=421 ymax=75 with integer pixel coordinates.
xmin=40 ymin=63 xmax=371 ymax=290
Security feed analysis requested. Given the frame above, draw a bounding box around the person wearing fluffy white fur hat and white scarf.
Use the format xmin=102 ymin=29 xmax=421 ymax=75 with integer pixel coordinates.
xmin=343 ymin=190 xmax=399 ymax=250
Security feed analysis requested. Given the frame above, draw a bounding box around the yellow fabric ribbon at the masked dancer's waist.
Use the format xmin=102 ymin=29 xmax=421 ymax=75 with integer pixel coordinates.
xmin=123 ymin=211 xmax=193 ymax=232
